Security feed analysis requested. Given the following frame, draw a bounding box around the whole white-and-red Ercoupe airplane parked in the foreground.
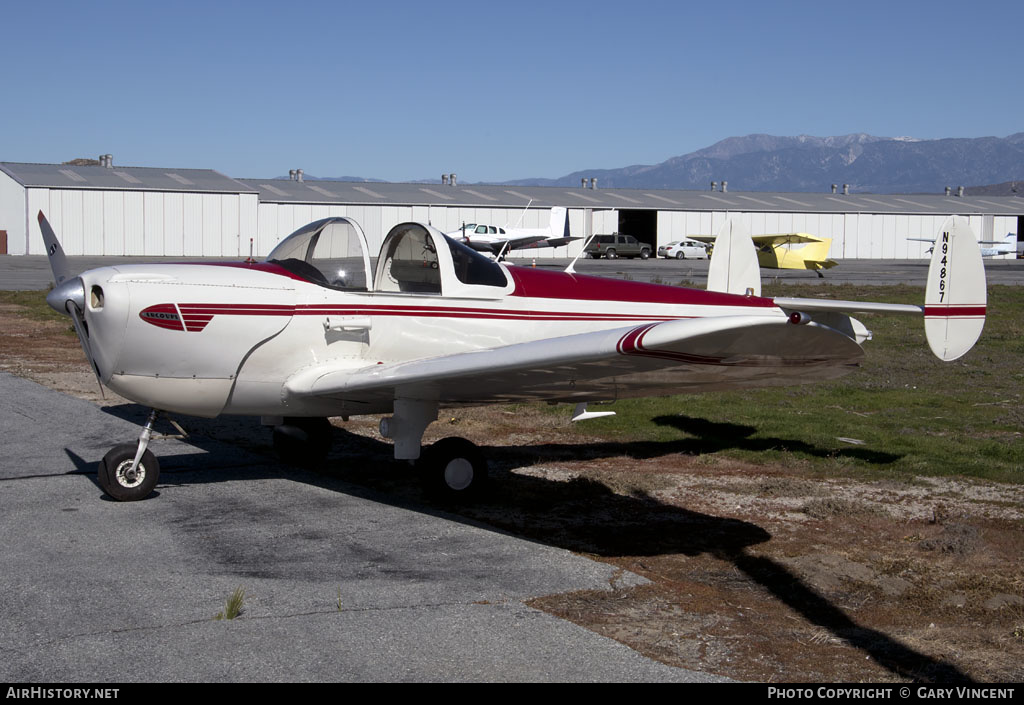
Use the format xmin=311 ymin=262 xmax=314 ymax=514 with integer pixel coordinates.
xmin=39 ymin=212 xmax=986 ymax=501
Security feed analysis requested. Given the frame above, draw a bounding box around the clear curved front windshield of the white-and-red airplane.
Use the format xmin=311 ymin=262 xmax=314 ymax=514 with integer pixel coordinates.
xmin=266 ymin=217 xmax=370 ymax=291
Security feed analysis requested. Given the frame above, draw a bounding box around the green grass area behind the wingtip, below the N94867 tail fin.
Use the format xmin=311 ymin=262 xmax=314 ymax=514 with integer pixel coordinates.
xmin=559 ymin=285 xmax=1024 ymax=483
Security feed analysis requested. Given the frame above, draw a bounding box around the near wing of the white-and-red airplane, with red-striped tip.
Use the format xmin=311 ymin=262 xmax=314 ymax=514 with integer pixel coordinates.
xmin=285 ymin=315 xmax=863 ymax=406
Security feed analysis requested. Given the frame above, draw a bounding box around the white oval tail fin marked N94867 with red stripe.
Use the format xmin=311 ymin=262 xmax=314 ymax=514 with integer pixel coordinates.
xmin=925 ymin=215 xmax=987 ymax=361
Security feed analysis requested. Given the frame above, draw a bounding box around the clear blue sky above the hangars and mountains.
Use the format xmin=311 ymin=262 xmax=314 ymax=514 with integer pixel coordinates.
xmin=0 ymin=0 xmax=1024 ymax=182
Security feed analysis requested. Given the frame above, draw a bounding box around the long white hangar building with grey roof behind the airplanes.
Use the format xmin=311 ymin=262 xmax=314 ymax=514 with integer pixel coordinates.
xmin=0 ymin=161 xmax=1024 ymax=259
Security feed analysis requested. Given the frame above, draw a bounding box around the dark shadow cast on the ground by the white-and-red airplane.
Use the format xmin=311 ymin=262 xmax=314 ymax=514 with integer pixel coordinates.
xmin=86 ymin=405 xmax=958 ymax=682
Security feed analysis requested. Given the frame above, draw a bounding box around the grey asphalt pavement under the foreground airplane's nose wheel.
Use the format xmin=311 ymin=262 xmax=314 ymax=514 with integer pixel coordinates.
xmin=0 ymin=373 xmax=717 ymax=682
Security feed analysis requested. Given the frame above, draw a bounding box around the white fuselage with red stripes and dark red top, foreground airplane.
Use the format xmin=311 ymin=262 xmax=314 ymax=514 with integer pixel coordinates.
xmin=74 ymin=263 xmax=786 ymax=416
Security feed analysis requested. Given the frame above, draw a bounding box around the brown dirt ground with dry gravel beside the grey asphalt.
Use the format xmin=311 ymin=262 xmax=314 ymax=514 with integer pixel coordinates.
xmin=0 ymin=304 xmax=1024 ymax=682
